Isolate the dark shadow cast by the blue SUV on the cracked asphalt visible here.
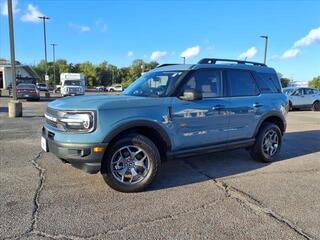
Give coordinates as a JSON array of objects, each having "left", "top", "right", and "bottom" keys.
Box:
[{"left": 147, "top": 130, "right": 320, "bottom": 191}]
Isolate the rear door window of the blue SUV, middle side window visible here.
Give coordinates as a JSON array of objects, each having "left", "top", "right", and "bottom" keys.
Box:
[{"left": 227, "top": 70, "right": 259, "bottom": 97}]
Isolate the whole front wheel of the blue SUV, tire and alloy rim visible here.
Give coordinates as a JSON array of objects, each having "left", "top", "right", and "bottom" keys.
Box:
[{"left": 101, "top": 134, "right": 161, "bottom": 192}]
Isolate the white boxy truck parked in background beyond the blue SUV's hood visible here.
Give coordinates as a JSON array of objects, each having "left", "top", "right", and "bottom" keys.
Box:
[{"left": 60, "top": 73, "right": 86, "bottom": 97}]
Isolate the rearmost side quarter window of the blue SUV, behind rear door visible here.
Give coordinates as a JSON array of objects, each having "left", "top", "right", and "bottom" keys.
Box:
[{"left": 255, "top": 73, "right": 281, "bottom": 93}]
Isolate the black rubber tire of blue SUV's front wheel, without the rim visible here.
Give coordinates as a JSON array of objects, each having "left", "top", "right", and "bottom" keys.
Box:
[{"left": 101, "top": 134, "right": 161, "bottom": 192}]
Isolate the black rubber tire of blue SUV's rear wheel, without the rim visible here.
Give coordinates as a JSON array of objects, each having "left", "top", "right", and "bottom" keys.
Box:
[{"left": 250, "top": 123, "right": 282, "bottom": 163}]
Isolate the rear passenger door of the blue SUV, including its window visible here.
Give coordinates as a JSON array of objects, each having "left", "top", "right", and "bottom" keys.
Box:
[{"left": 226, "top": 69, "right": 266, "bottom": 142}]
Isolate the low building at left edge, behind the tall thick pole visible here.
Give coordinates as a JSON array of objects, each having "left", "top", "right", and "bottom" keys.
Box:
[{"left": 0, "top": 60, "right": 38, "bottom": 89}]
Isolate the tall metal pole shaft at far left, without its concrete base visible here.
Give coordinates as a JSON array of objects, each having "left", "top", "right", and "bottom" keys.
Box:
[{"left": 8, "top": 0, "right": 17, "bottom": 100}]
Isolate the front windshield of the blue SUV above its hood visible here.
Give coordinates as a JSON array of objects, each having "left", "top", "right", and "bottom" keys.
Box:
[{"left": 123, "top": 71, "right": 183, "bottom": 97}]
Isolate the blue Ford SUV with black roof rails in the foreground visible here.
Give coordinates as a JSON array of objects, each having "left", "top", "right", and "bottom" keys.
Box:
[{"left": 41, "top": 58, "right": 288, "bottom": 192}]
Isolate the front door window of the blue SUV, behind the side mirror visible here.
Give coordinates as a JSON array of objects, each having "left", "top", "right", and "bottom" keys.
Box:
[{"left": 183, "top": 69, "right": 222, "bottom": 98}]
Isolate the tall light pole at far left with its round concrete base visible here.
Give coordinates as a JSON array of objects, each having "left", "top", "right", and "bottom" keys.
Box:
[{"left": 7, "top": 0, "right": 22, "bottom": 117}]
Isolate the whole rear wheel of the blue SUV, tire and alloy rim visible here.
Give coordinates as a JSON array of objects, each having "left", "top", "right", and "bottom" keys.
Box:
[{"left": 250, "top": 123, "right": 282, "bottom": 162}]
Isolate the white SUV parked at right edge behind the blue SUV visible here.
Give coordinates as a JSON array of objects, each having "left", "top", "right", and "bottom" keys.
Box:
[{"left": 283, "top": 87, "right": 320, "bottom": 111}]
